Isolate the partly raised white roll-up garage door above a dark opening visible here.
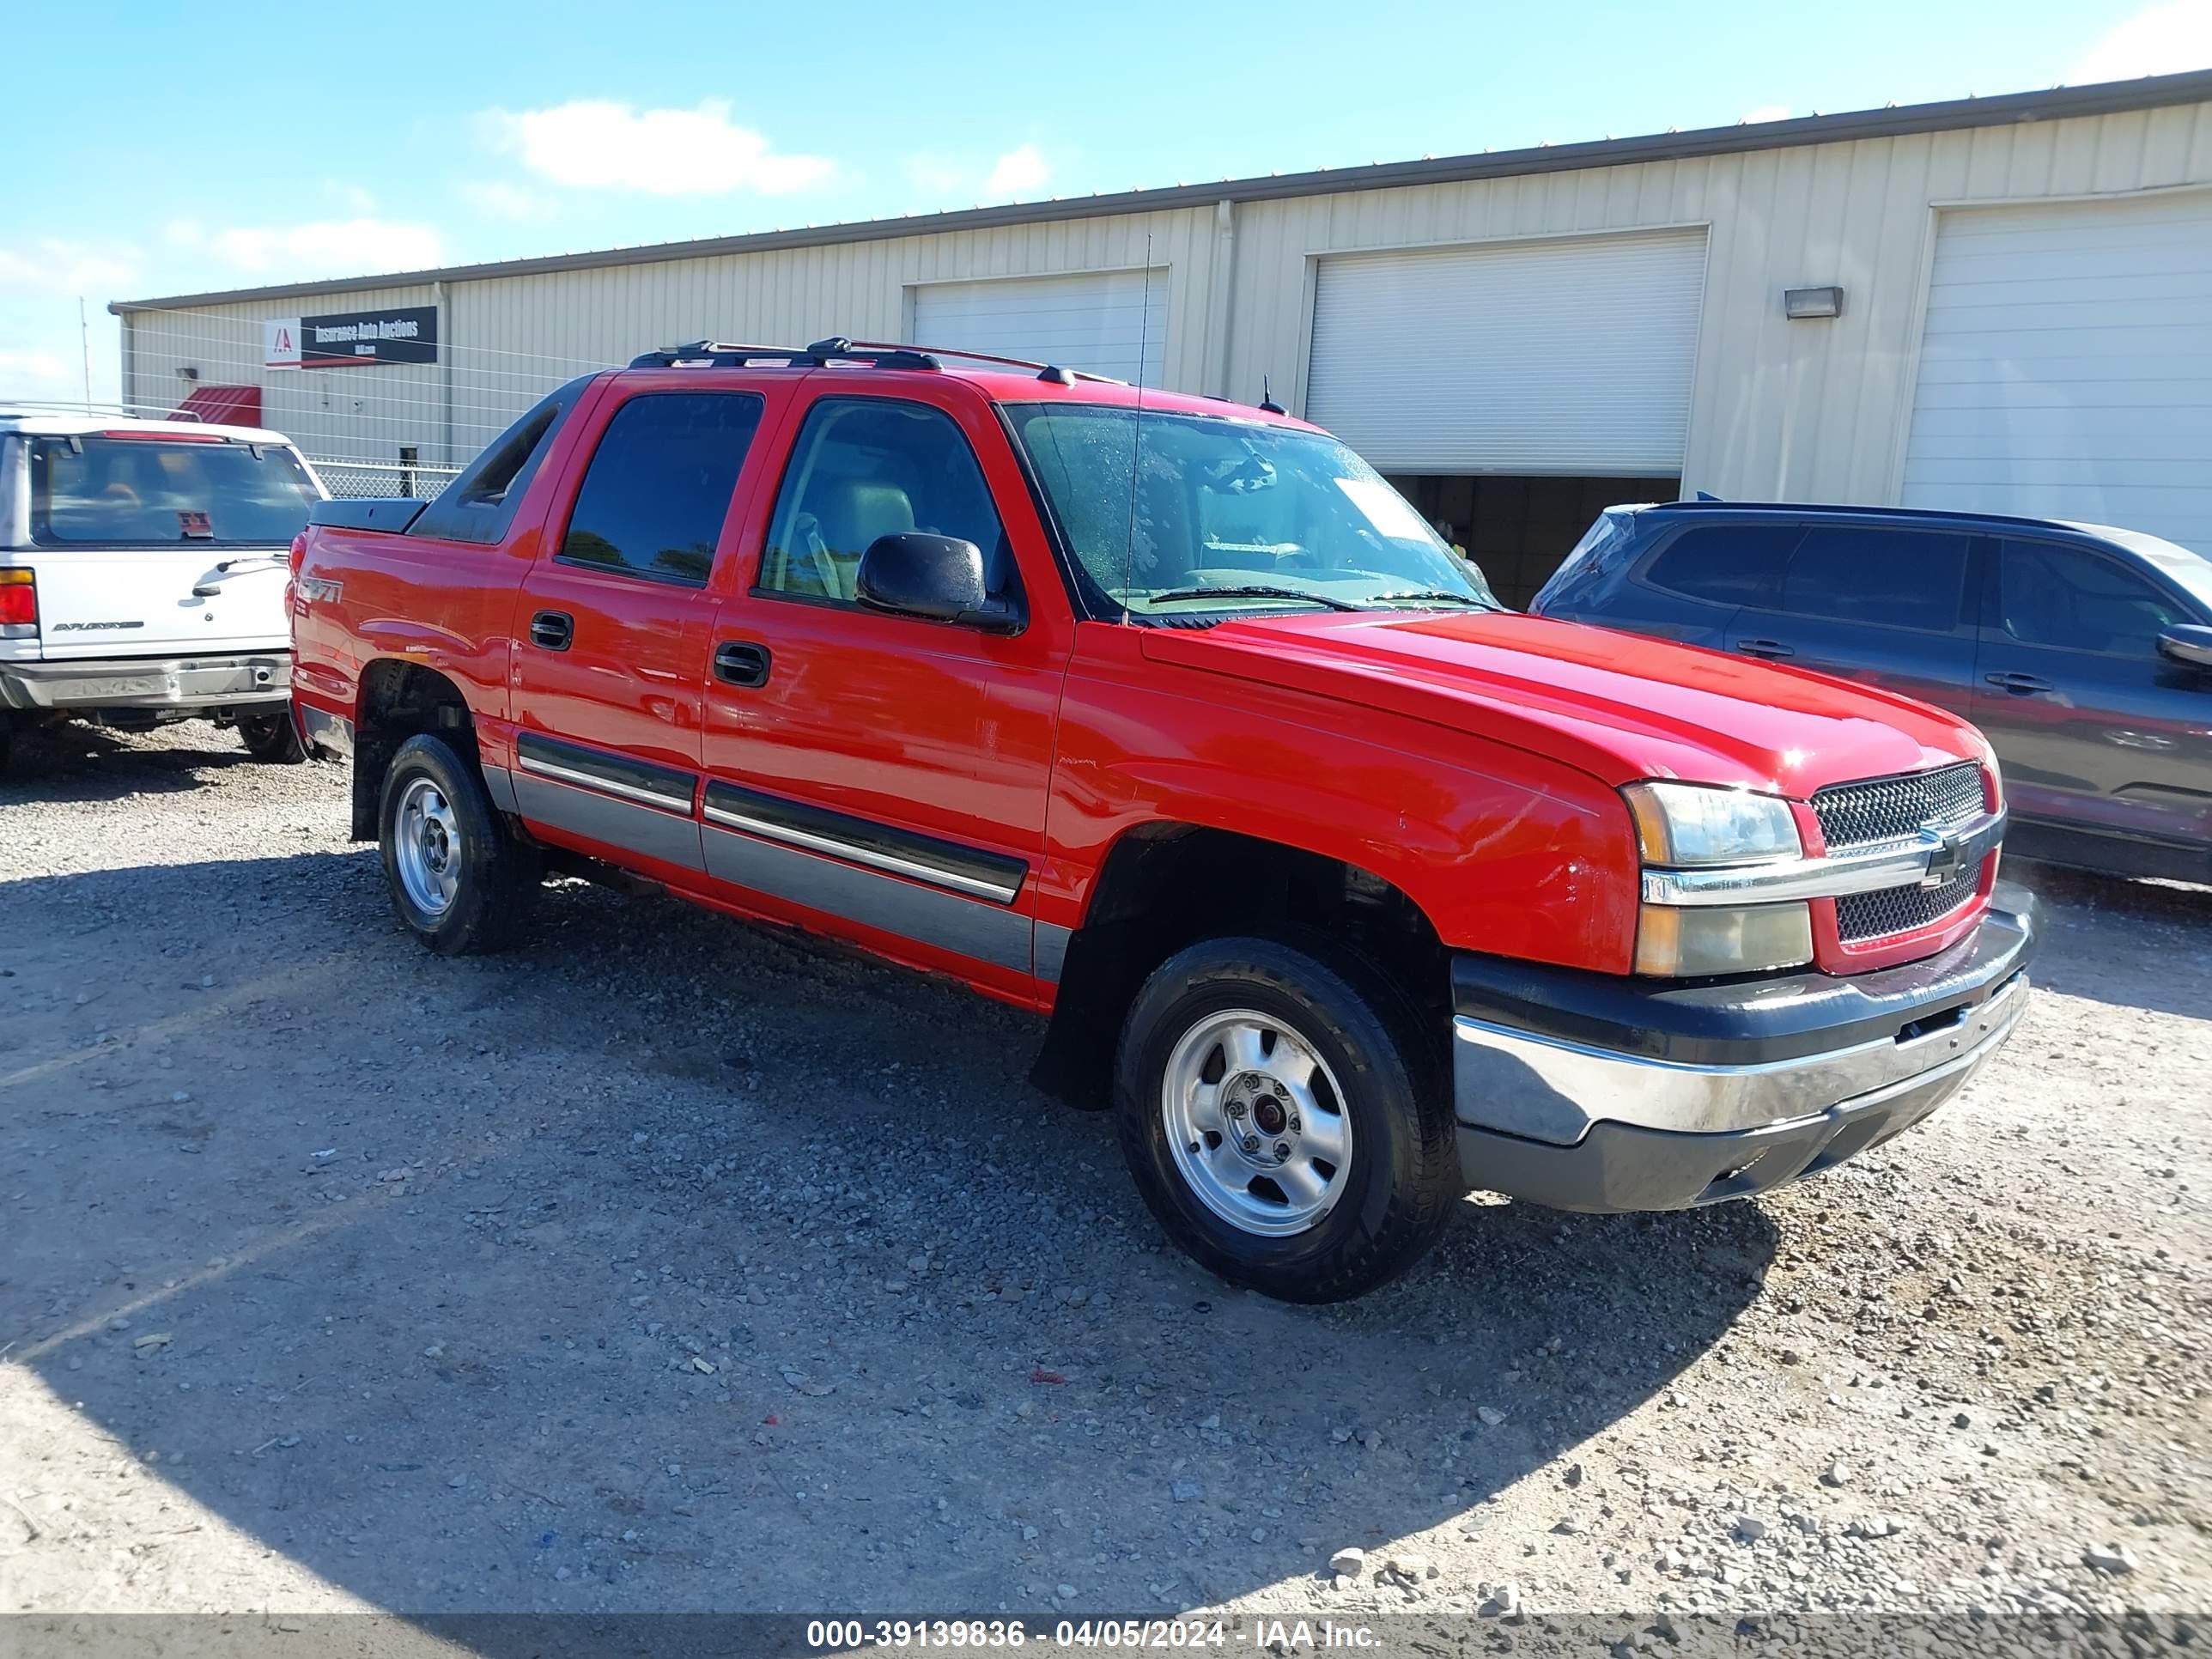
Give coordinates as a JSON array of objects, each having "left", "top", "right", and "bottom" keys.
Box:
[{"left": 1305, "top": 230, "right": 1705, "bottom": 476}]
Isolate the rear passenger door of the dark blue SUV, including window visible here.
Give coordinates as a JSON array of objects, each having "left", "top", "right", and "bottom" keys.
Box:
[{"left": 1729, "top": 522, "right": 1973, "bottom": 714}]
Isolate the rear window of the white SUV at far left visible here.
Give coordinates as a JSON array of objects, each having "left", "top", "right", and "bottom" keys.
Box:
[{"left": 31, "top": 435, "right": 319, "bottom": 546}]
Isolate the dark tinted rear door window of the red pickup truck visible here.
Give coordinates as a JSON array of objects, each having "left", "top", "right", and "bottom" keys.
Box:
[{"left": 556, "top": 392, "right": 763, "bottom": 586}]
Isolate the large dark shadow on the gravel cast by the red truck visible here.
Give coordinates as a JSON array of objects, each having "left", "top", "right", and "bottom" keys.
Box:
[{"left": 0, "top": 852, "right": 1777, "bottom": 1650}]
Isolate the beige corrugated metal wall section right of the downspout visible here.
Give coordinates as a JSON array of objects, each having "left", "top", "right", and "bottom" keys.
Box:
[{"left": 1228, "top": 93, "right": 2212, "bottom": 502}]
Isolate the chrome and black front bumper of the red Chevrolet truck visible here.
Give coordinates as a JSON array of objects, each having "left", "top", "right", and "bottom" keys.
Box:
[{"left": 1451, "top": 887, "right": 2037, "bottom": 1210}]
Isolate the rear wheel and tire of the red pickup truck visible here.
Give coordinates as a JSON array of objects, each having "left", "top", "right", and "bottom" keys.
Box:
[{"left": 376, "top": 734, "right": 540, "bottom": 956}]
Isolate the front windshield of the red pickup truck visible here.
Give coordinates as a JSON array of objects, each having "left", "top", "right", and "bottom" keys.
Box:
[{"left": 1009, "top": 403, "right": 1500, "bottom": 617}]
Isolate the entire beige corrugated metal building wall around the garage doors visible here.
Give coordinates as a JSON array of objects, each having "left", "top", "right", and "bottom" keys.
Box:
[{"left": 124, "top": 104, "right": 2212, "bottom": 502}]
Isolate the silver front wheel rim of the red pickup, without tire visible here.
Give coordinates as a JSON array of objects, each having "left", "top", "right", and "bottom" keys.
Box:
[{"left": 1159, "top": 1009, "right": 1352, "bottom": 1239}]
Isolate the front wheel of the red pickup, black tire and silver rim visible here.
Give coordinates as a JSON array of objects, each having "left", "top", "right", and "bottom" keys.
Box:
[{"left": 1115, "top": 938, "right": 1467, "bottom": 1303}]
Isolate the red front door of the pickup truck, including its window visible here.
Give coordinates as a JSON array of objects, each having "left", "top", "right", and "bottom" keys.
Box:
[{"left": 702, "top": 393, "right": 1071, "bottom": 1000}]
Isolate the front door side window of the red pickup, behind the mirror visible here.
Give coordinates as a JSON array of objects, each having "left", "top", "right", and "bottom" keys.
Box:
[{"left": 754, "top": 398, "right": 1013, "bottom": 604}]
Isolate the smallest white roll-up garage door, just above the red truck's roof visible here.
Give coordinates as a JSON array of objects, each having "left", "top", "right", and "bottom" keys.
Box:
[{"left": 914, "top": 270, "right": 1168, "bottom": 387}]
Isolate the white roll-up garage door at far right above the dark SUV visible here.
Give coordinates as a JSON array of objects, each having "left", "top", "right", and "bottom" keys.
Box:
[{"left": 1905, "top": 191, "right": 2212, "bottom": 553}]
